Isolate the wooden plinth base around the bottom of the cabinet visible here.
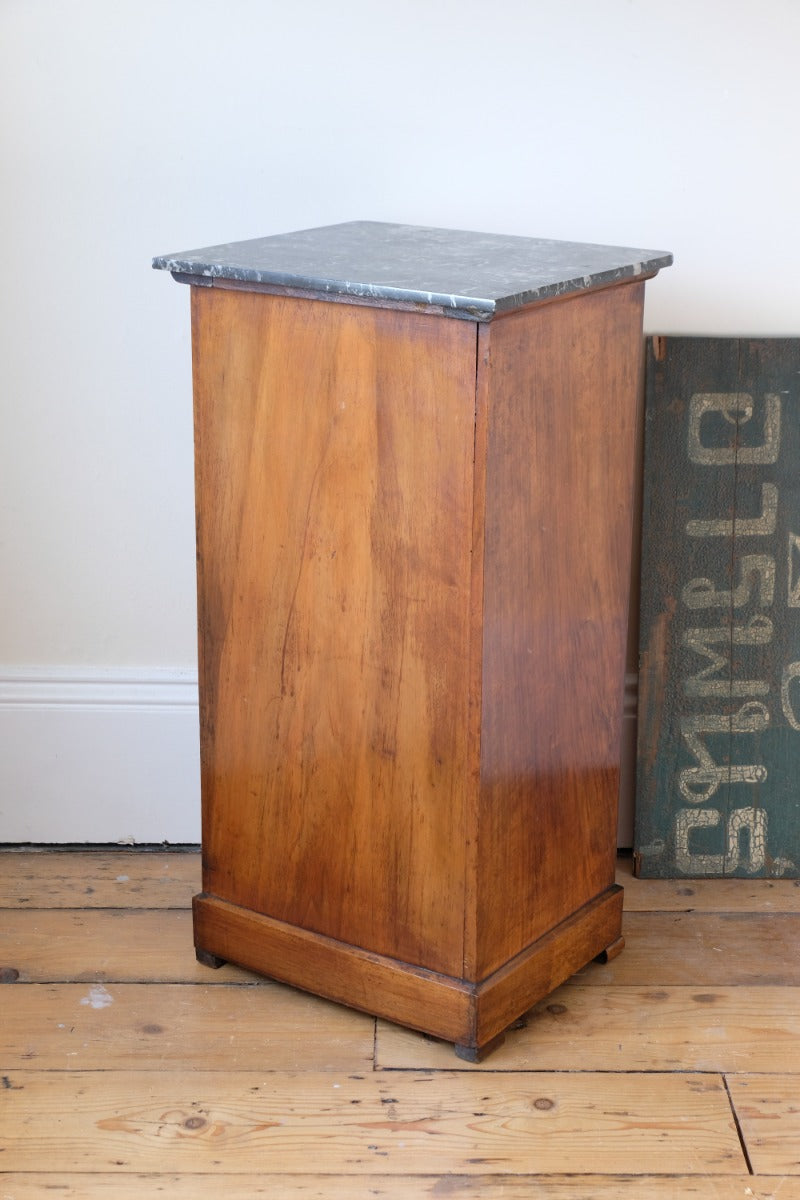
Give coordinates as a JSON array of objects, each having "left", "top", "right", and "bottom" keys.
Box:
[{"left": 193, "top": 884, "right": 622, "bottom": 1062}]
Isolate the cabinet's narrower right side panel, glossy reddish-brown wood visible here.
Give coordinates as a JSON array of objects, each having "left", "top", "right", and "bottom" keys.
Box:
[{"left": 479, "top": 284, "right": 644, "bottom": 978}]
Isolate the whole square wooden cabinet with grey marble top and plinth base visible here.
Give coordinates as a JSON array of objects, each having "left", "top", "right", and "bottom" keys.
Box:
[{"left": 154, "top": 222, "right": 672, "bottom": 1060}]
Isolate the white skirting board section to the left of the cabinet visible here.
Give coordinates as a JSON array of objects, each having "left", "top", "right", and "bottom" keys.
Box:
[{"left": 0, "top": 666, "right": 200, "bottom": 844}]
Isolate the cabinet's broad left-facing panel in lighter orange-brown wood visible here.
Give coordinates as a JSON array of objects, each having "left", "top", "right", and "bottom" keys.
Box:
[{"left": 193, "top": 288, "right": 475, "bottom": 976}]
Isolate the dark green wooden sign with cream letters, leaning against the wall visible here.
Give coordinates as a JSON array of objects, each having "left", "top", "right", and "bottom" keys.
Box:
[{"left": 634, "top": 337, "right": 800, "bottom": 878}]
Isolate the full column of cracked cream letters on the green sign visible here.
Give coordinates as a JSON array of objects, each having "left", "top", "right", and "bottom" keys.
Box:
[{"left": 674, "top": 392, "right": 800, "bottom": 875}]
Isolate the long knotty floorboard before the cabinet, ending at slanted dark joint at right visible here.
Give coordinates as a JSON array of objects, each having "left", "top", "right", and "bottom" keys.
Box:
[{"left": 0, "top": 1070, "right": 744, "bottom": 1176}]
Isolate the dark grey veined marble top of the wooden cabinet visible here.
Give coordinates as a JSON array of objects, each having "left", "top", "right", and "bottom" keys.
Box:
[{"left": 152, "top": 221, "right": 672, "bottom": 320}]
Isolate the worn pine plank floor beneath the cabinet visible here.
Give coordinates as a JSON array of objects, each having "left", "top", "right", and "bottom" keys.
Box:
[{"left": 0, "top": 852, "right": 800, "bottom": 1200}]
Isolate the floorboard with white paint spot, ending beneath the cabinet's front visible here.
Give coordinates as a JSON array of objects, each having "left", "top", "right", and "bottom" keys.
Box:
[{"left": 0, "top": 983, "right": 374, "bottom": 1070}]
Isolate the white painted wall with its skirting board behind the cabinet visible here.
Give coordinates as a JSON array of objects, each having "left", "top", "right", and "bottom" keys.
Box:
[{"left": 0, "top": 0, "right": 800, "bottom": 841}]
